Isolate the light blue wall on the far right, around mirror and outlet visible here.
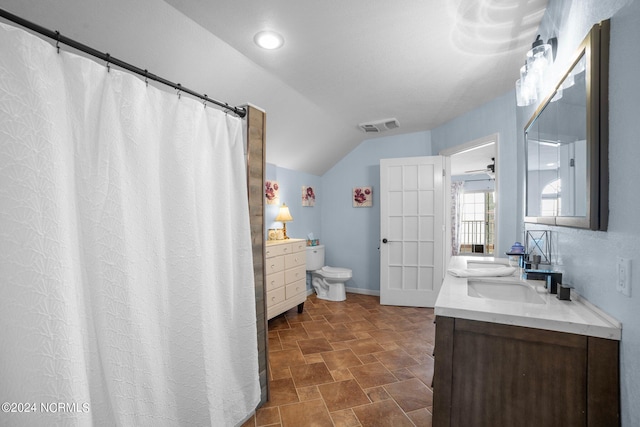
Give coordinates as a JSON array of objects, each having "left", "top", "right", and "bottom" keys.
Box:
[{"left": 518, "top": 0, "right": 640, "bottom": 427}]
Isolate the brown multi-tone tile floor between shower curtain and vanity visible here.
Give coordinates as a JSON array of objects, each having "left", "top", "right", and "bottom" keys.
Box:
[{"left": 243, "top": 293, "right": 435, "bottom": 427}]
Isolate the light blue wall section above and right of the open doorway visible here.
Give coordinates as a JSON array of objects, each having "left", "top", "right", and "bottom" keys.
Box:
[{"left": 431, "top": 91, "right": 524, "bottom": 256}]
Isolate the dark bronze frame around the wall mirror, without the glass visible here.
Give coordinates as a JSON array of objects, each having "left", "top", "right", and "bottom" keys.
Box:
[{"left": 524, "top": 20, "right": 610, "bottom": 231}]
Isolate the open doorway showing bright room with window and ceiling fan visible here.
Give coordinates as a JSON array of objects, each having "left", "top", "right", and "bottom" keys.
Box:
[{"left": 439, "top": 133, "right": 499, "bottom": 260}]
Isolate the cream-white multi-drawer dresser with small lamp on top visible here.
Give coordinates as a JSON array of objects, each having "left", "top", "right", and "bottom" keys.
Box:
[{"left": 265, "top": 239, "right": 307, "bottom": 319}]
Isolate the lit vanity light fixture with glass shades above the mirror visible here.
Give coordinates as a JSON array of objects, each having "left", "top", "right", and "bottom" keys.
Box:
[{"left": 516, "top": 35, "right": 558, "bottom": 107}]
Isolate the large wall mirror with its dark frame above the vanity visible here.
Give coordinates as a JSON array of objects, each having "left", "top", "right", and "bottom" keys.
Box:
[{"left": 525, "top": 21, "right": 609, "bottom": 230}]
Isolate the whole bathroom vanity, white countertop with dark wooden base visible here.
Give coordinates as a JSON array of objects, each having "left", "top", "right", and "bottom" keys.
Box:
[{"left": 433, "top": 257, "right": 621, "bottom": 427}]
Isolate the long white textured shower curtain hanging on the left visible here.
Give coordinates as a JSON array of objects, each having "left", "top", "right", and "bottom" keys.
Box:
[{"left": 0, "top": 24, "right": 260, "bottom": 426}]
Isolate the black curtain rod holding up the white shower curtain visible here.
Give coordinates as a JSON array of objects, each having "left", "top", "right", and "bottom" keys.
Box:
[{"left": 0, "top": 9, "right": 247, "bottom": 118}]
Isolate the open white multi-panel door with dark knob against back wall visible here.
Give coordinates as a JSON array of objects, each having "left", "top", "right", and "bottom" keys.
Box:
[{"left": 380, "top": 156, "right": 445, "bottom": 307}]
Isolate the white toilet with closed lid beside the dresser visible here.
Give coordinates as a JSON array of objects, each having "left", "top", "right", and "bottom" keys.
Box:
[{"left": 307, "top": 245, "right": 351, "bottom": 301}]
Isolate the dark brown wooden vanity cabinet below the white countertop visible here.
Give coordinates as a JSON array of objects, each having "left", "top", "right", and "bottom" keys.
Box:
[{"left": 433, "top": 316, "right": 620, "bottom": 427}]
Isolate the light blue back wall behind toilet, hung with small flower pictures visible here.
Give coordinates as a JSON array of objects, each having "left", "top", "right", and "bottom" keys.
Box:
[{"left": 265, "top": 132, "right": 431, "bottom": 295}]
